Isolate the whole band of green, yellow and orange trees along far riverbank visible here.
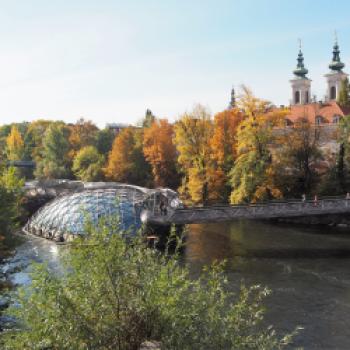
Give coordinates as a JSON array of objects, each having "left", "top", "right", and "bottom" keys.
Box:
[{"left": 0, "top": 88, "right": 350, "bottom": 203}]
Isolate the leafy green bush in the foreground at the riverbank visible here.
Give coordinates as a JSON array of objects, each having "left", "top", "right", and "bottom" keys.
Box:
[{"left": 2, "top": 225, "right": 298, "bottom": 350}]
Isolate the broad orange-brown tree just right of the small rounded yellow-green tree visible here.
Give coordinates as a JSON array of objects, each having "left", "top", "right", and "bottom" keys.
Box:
[{"left": 104, "top": 127, "right": 151, "bottom": 186}]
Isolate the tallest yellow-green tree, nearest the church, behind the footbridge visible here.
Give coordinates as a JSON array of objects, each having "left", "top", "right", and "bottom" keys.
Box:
[{"left": 230, "top": 88, "right": 285, "bottom": 204}]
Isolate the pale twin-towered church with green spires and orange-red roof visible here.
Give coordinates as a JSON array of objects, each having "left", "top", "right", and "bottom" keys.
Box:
[{"left": 286, "top": 40, "right": 350, "bottom": 127}]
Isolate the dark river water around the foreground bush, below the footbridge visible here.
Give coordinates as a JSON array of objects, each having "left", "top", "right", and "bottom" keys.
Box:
[{"left": 2, "top": 221, "right": 350, "bottom": 349}]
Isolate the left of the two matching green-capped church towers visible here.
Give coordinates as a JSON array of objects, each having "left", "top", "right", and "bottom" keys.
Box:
[{"left": 290, "top": 45, "right": 311, "bottom": 105}]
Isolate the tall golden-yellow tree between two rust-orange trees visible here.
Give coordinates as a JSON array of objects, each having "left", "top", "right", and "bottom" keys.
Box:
[{"left": 174, "top": 105, "right": 213, "bottom": 203}]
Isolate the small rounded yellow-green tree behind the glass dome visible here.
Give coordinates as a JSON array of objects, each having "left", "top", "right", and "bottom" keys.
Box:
[{"left": 72, "top": 146, "right": 104, "bottom": 181}]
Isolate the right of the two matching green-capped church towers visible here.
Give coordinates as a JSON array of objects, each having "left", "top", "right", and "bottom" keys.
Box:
[{"left": 325, "top": 39, "right": 348, "bottom": 101}]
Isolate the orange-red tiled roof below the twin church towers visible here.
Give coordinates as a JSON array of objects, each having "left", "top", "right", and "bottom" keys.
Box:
[{"left": 286, "top": 101, "right": 350, "bottom": 124}]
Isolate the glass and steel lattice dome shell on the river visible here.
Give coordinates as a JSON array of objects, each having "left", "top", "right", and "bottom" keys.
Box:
[{"left": 24, "top": 189, "right": 141, "bottom": 241}]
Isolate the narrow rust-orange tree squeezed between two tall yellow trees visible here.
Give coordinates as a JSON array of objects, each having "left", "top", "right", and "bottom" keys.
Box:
[{"left": 210, "top": 108, "right": 242, "bottom": 202}]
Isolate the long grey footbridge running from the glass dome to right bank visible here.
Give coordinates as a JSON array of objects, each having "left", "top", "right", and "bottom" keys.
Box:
[{"left": 143, "top": 196, "right": 350, "bottom": 225}]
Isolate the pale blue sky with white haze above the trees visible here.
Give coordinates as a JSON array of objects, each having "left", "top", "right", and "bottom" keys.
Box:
[{"left": 0, "top": 0, "right": 350, "bottom": 127}]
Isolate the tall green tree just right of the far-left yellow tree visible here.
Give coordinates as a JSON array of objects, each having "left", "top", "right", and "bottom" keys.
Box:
[{"left": 35, "top": 124, "right": 71, "bottom": 179}]
